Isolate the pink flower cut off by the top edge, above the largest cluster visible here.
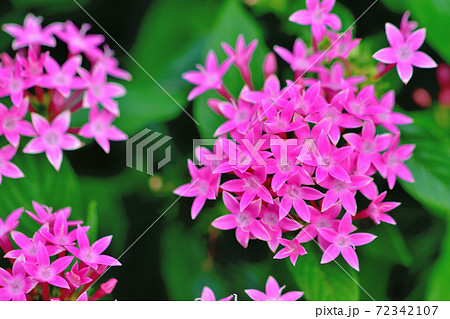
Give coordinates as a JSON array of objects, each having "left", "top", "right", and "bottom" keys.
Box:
[{"left": 289, "top": 0, "right": 342, "bottom": 42}]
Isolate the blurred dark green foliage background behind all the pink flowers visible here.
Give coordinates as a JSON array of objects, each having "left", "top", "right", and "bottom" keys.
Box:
[{"left": 0, "top": 0, "right": 450, "bottom": 300}]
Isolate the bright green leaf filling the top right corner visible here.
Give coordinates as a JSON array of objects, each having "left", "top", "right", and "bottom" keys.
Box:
[{"left": 383, "top": 0, "right": 450, "bottom": 62}]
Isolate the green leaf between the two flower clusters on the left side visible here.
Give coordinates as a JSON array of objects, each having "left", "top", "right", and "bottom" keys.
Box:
[{"left": 0, "top": 153, "right": 84, "bottom": 233}]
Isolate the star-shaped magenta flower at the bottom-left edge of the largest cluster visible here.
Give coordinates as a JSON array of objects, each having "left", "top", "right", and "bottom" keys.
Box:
[{"left": 211, "top": 192, "right": 270, "bottom": 248}]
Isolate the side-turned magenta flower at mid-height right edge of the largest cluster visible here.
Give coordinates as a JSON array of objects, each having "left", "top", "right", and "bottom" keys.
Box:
[{"left": 383, "top": 135, "right": 415, "bottom": 189}]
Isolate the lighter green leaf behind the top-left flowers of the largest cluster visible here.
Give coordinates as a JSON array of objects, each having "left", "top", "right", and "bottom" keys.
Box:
[{"left": 193, "top": 0, "right": 268, "bottom": 138}]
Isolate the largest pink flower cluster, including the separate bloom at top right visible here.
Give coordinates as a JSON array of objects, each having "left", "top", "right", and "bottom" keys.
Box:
[{"left": 174, "top": 0, "right": 431, "bottom": 270}]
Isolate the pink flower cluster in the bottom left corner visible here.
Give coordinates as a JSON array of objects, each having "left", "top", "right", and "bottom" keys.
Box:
[{"left": 0, "top": 202, "right": 121, "bottom": 301}]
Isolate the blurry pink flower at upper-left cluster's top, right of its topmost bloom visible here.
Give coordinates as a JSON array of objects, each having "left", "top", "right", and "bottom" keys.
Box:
[{"left": 56, "top": 21, "right": 105, "bottom": 58}]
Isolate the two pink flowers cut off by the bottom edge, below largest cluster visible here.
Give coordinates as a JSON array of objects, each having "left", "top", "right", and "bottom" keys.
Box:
[{"left": 195, "top": 276, "right": 303, "bottom": 301}]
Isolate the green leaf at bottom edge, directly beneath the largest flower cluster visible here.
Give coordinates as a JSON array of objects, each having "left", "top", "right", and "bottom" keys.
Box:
[{"left": 288, "top": 247, "right": 359, "bottom": 301}]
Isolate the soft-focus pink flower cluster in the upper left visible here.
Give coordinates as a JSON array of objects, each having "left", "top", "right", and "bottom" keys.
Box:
[{"left": 0, "top": 14, "right": 131, "bottom": 178}]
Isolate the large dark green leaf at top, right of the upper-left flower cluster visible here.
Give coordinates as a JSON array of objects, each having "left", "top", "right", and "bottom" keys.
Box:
[{"left": 117, "top": 0, "right": 219, "bottom": 134}]
